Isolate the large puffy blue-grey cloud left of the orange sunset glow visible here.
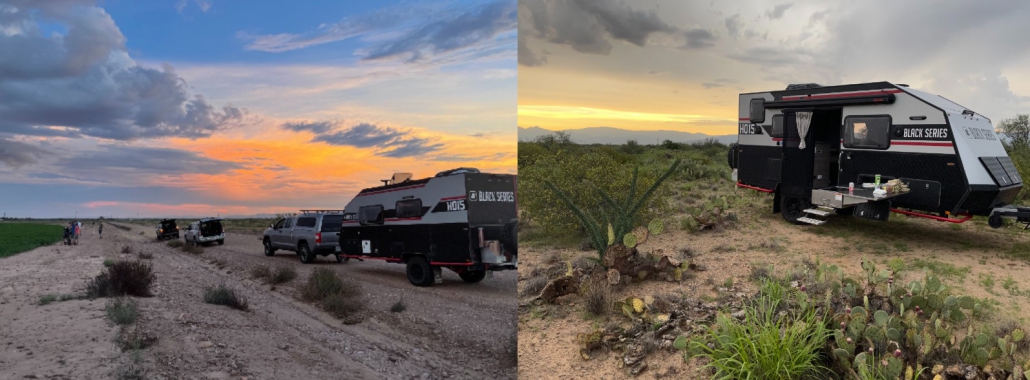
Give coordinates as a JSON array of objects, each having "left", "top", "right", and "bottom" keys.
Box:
[{"left": 0, "top": 1, "right": 245, "bottom": 140}]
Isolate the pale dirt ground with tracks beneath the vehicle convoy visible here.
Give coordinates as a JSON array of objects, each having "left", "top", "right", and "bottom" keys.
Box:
[{"left": 0, "top": 220, "right": 516, "bottom": 379}]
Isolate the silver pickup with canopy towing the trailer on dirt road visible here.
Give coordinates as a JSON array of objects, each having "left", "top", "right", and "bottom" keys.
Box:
[{"left": 262, "top": 210, "right": 347, "bottom": 264}]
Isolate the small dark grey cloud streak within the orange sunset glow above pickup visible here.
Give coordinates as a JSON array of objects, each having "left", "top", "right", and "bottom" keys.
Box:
[{"left": 280, "top": 122, "right": 444, "bottom": 158}]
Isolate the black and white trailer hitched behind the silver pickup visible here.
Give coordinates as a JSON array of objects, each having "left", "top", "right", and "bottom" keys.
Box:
[{"left": 340, "top": 168, "right": 518, "bottom": 286}]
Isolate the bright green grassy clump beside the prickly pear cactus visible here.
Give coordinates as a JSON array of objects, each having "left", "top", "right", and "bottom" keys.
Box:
[{"left": 691, "top": 281, "right": 830, "bottom": 379}]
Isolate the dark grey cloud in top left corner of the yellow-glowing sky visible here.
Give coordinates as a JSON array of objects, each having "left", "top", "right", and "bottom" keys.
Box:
[{"left": 519, "top": 0, "right": 688, "bottom": 66}]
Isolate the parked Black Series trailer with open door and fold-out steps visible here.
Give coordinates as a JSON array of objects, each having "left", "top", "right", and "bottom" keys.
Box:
[{"left": 728, "top": 81, "right": 1030, "bottom": 228}]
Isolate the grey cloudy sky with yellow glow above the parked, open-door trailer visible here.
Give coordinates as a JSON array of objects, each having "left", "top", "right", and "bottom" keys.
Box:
[{"left": 518, "top": 0, "right": 1030, "bottom": 135}]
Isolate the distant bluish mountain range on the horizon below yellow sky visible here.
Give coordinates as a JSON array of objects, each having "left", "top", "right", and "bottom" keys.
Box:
[{"left": 518, "top": 127, "right": 736, "bottom": 144}]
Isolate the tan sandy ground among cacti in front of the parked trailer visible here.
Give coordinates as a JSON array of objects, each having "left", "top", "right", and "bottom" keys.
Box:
[{"left": 518, "top": 199, "right": 1030, "bottom": 379}]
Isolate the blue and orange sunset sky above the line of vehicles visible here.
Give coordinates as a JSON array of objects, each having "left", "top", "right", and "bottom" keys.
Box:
[{"left": 0, "top": 0, "right": 518, "bottom": 217}]
